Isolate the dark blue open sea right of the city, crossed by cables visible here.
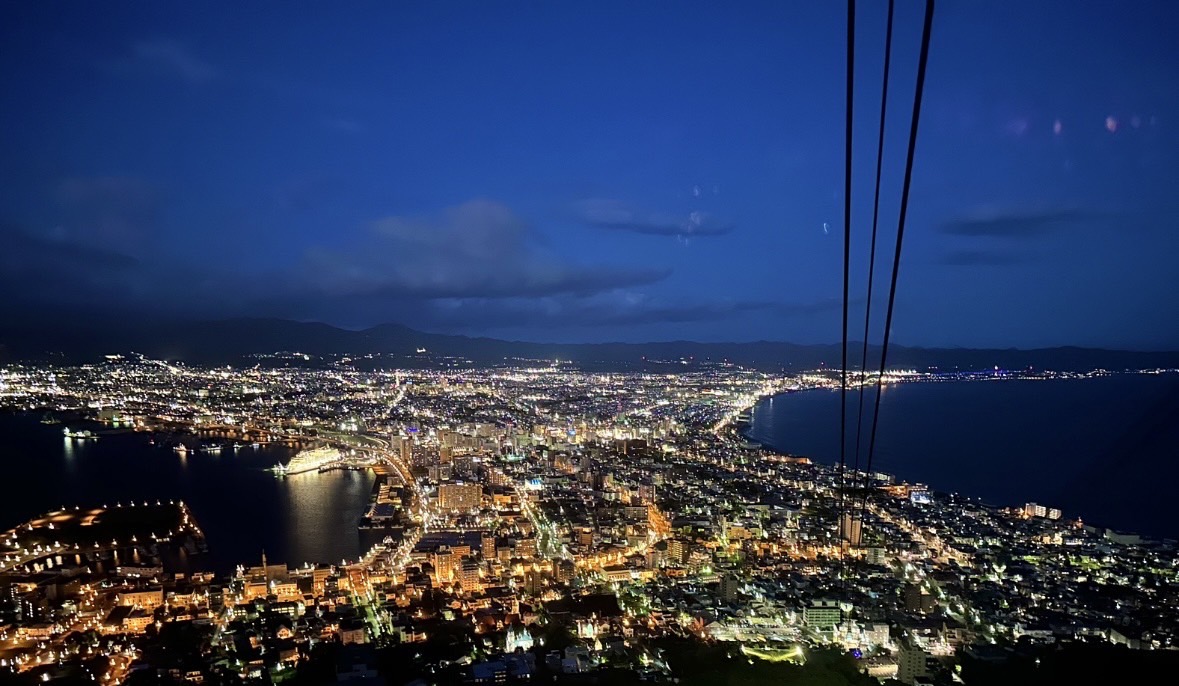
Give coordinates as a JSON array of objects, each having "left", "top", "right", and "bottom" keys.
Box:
[{"left": 747, "top": 374, "right": 1179, "bottom": 537}]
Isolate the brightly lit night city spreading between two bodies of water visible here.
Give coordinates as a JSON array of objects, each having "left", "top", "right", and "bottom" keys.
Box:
[{"left": 0, "top": 356, "right": 1179, "bottom": 684}]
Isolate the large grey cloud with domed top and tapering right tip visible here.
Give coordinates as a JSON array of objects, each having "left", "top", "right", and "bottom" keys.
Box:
[{"left": 301, "top": 200, "right": 668, "bottom": 298}]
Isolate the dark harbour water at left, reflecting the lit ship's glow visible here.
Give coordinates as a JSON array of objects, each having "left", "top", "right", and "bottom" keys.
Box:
[{"left": 0, "top": 413, "right": 374, "bottom": 572}]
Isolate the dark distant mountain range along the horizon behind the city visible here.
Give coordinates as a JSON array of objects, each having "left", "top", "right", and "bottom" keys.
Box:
[{"left": 0, "top": 317, "right": 1179, "bottom": 371}]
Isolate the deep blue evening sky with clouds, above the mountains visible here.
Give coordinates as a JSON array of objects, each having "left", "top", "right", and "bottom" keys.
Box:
[{"left": 0, "top": 0, "right": 1179, "bottom": 348}]
